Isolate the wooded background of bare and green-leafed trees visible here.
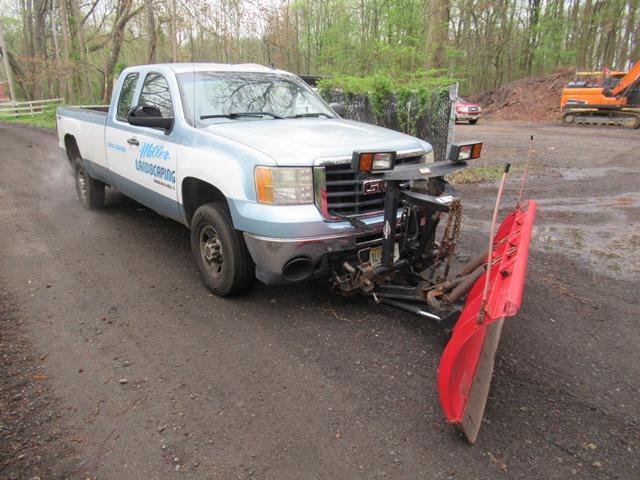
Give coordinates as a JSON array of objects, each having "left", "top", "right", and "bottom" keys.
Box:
[{"left": 0, "top": 0, "right": 640, "bottom": 104}]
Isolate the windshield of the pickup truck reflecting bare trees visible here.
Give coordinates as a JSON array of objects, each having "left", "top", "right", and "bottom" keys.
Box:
[{"left": 177, "top": 72, "right": 335, "bottom": 127}]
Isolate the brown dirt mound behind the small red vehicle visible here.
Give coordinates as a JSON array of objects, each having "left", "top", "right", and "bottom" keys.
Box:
[{"left": 469, "top": 70, "right": 573, "bottom": 122}]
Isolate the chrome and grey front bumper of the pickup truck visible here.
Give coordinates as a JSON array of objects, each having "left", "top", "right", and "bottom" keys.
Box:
[{"left": 244, "top": 222, "right": 382, "bottom": 285}]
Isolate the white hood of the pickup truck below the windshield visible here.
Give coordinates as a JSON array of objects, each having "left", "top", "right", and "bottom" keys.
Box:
[{"left": 206, "top": 118, "right": 431, "bottom": 166}]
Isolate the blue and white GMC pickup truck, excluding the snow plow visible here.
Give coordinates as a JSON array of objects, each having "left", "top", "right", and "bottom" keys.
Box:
[{"left": 57, "top": 64, "right": 433, "bottom": 295}]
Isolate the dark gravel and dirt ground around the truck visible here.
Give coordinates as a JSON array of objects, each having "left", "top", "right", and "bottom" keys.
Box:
[{"left": 0, "top": 119, "right": 640, "bottom": 480}]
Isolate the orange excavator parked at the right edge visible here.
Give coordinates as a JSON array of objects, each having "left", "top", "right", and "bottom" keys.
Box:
[{"left": 560, "top": 61, "right": 640, "bottom": 128}]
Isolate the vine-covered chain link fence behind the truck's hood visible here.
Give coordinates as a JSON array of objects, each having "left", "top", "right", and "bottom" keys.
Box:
[{"left": 322, "top": 86, "right": 457, "bottom": 161}]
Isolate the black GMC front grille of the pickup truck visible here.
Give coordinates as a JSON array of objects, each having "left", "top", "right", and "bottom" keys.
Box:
[{"left": 325, "top": 156, "right": 422, "bottom": 217}]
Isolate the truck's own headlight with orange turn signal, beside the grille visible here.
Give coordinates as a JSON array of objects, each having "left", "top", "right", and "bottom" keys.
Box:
[{"left": 255, "top": 167, "right": 313, "bottom": 205}]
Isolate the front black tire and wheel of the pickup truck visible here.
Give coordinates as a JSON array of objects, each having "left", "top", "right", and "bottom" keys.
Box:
[{"left": 191, "top": 202, "right": 255, "bottom": 297}]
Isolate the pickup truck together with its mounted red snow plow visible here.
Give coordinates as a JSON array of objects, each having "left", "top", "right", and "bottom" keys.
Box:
[{"left": 57, "top": 65, "right": 536, "bottom": 443}]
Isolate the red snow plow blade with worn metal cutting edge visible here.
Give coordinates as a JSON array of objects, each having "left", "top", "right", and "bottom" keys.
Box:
[{"left": 438, "top": 200, "right": 536, "bottom": 444}]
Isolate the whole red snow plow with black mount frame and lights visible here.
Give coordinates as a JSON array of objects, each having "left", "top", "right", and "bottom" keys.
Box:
[{"left": 333, "top": 142, "right": 536, "bottom": 443}]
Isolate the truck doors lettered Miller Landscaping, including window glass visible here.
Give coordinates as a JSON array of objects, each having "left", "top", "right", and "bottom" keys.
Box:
[{"left": 107, "top": 72, "right": 181, "bottom": 221}]
